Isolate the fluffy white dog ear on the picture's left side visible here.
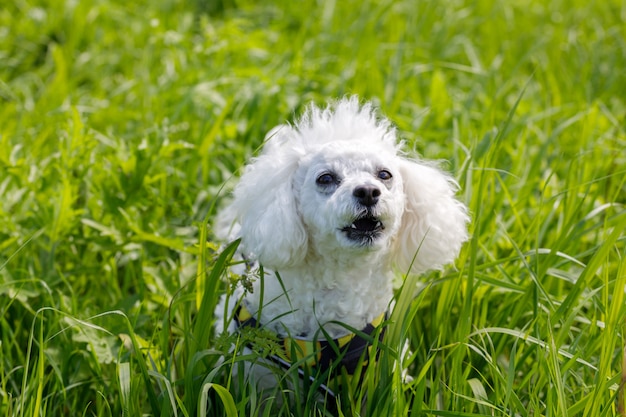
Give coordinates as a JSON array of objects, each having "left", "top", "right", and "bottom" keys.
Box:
[{"left": 227, "top": 125, "right": 308, "bottom": 269}]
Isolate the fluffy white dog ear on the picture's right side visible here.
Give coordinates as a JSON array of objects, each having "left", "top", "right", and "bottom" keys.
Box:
[{"left": 393, "top": 159, "right": 469, "bottom": 273}]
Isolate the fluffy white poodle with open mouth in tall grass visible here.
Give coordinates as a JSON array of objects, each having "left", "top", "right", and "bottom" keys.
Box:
[{"left": 217, "top": 97, "right": 468, "bottom": 402}]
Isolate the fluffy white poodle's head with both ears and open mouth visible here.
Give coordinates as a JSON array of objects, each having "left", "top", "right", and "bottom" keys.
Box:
[{"left": 224, "top": 97, "right": 468, "bottom": 272}]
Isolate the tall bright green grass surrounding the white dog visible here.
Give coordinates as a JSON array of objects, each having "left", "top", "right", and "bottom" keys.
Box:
[{"left": 0, "top": 0, "right": 626, "bottom": 417}]
